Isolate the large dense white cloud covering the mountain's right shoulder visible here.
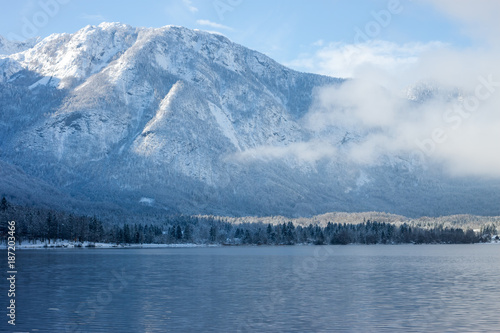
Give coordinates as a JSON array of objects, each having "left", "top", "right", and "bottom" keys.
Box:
[{"left": 298, "top": 43, "right": 500, "bottom": 177}]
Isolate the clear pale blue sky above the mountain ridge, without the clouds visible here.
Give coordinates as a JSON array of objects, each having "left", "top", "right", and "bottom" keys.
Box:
[{"left": 0, "top": 0, "right": 474, "bottom": 74}]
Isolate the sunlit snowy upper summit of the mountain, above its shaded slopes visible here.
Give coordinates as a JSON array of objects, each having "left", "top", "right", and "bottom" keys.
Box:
[{"left": 3, "top": 22, "right": 290, "bottom": 88}]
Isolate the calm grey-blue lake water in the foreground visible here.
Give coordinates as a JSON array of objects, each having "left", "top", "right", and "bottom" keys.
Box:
[{"left": 5, "top": 245, "right": 500, "bottom": 332}]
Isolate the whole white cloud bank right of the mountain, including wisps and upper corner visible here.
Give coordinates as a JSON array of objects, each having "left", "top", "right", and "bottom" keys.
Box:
[{"left": 236, "top": 0, "right": 500, "bottom": 178}]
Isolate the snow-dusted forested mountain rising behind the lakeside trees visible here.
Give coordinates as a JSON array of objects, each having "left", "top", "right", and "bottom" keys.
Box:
[{"left": 0, "top": 23, "right": 500, "bottom": 215}]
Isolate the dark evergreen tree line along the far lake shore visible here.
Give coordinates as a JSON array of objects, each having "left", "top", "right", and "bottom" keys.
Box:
[{"left": 0, "top": 198, "right": 497, "bottom": 245}]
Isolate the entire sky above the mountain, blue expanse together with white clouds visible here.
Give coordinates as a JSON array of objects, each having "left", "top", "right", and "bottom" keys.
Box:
[{"left": 0, "top": 0, "right": 500, "bottom": 178}]
